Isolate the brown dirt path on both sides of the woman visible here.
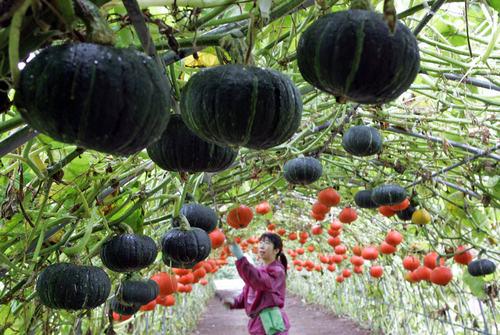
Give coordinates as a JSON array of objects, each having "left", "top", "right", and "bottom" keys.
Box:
[{"left": 192, "top": 291, "right": 370, "bottom": 335}]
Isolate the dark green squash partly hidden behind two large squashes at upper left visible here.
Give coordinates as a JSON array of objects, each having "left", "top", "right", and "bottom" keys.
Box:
[{"left": 148, "top": 115, "right": 238, "bottom": 172}]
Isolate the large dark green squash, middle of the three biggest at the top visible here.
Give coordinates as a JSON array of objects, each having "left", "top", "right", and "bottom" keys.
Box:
[{"left": 181, "top": 65, "right": 302, "bottom": 149}]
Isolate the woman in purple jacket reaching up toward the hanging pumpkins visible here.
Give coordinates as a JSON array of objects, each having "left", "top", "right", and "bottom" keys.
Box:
[{"left": 224, "top": 233, "right": 290, "bottom": 335}]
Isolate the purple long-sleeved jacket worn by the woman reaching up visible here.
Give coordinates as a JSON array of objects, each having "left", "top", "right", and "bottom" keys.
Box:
[{"left": 231, "top": 257, "right": 290, "bottom": 335}]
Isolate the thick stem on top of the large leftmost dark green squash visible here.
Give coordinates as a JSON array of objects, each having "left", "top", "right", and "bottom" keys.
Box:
[{"left": 74, "top": 0, "right": 115, "bottom": 45}]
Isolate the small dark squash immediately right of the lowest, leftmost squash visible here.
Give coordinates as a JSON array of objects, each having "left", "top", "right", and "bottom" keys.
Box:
[{"left": 118, "top": 279, "right": 160, "bottom": 305}]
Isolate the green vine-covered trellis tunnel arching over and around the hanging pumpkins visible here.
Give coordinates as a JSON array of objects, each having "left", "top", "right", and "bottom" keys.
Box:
[{"left": 0, "top": 0, "right": 500, "bottom": 334}]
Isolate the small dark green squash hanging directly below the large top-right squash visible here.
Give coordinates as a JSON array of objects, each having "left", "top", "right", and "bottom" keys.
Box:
[{"left": 342, "top": 126, "right": 382, "bottom": 157}]
